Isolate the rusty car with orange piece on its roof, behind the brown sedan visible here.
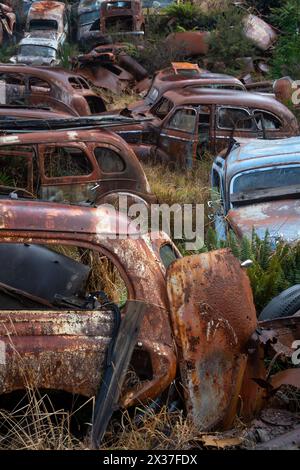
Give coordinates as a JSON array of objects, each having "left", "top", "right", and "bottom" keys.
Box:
[{"left": 129, "top": 62, "right": 246, "bottom": 112}]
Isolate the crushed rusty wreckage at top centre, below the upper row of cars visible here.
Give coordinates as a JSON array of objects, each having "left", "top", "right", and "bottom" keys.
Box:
[{"left": 72, "top": 44, "right": 149, "bottom": 93}]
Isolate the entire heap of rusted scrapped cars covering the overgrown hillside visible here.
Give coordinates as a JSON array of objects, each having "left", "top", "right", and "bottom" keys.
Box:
[{"left": 0, "top": 0, "right": 300, "bottom": 447}]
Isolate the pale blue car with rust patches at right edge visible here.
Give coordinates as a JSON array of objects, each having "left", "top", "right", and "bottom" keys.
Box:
[{"left": 211, "top": 137, "right": 300, "bottom": 242}]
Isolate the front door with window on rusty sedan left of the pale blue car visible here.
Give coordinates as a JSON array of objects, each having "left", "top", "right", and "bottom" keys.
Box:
[{"left": 155, "top": 106, "right": 198, "bottom": 169}]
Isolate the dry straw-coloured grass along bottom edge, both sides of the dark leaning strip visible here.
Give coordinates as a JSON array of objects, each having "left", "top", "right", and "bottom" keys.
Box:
[{"left": 0, "top": 388, "right": 199, "bottom": 450}]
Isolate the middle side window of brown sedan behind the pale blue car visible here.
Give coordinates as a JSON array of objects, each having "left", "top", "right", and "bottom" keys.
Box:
[{"left": 218, "top": 107, "right": 256, "bottom": 131}]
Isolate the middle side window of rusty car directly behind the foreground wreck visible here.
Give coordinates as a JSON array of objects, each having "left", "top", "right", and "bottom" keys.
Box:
[{"left": 44, "top": 146, "right": 93, "bottom": 178}]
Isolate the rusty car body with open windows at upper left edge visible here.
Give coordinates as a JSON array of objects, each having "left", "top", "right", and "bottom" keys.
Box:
[{"left": 0, "top": 65, "right": 106, "bottom": 116}]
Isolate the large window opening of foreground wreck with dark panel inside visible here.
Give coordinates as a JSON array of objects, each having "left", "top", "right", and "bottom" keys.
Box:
[{"left": 0, "top": 243, "right": 128, "bottom": 310}]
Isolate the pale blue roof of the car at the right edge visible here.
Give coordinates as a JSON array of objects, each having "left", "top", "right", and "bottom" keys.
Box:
[{"left": 225, "top": 137, "right": 300, "bottom": 180}]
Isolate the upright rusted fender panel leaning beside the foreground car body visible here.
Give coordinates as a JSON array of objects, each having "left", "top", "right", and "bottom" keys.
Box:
[{"left": 167, "top": 250, "right": 261, "bottom": 430}]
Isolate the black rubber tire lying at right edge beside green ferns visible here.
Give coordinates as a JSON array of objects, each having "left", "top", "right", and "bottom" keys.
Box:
[{"left": 258, "top": 284, "right": 300, "bottom": 321}]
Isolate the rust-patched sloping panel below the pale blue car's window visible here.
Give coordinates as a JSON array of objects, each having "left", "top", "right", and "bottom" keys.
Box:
[{"left": 227, "top": 199, "right": 300, "bottom": 242}]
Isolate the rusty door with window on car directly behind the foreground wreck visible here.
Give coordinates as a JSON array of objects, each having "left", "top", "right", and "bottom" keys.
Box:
[{"left": 39, "top": 142, "right": 100, "bottom": 204}]
